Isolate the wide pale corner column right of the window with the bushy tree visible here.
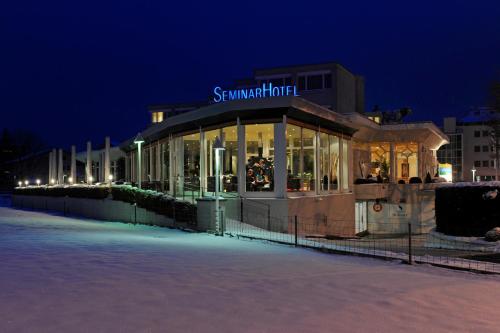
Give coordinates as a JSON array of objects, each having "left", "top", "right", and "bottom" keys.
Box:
[{"left": 274, "top": 116, "right": 287, "bottom": 198}]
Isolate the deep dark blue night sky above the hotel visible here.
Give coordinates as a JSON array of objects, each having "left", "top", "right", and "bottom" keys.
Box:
[{"left": 0, "top": 0, "right": 500, "bottom": 146}]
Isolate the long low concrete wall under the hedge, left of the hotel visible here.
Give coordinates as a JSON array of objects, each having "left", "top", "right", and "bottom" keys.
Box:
[{"left": 12, "top": 195, "right": 176, "bottom": 227}]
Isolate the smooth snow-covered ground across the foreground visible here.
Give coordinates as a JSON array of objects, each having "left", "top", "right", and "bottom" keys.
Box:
[{"left": 0, "top": 198, "right": 500, "bottom": 332}]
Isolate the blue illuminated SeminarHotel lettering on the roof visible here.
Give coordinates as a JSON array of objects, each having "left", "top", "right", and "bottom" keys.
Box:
[{"left": 214, "top": 82, "right": 299, "bottom": 103}]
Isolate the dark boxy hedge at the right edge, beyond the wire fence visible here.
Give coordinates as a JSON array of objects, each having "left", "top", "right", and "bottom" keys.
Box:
[{"left": 435, "top": 183, "right": 500, "bottom": 237}]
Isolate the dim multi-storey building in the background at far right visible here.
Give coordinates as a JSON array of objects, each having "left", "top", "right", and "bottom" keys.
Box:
[{"left": 437, "top": 107, "right": 497, "bottom": 182}]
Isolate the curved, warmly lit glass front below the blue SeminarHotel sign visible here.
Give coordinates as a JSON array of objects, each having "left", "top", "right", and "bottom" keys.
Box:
[{"left": 131, "top": 123, "right": 350, "bottom": 196}]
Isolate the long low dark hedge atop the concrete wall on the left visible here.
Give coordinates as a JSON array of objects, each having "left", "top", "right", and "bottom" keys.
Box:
[{"left": 14, "top": 185, "right": 196, "bottom": 224}]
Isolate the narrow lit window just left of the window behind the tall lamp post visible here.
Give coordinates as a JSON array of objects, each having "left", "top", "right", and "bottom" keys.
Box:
[{"left": 182, "top": 133, "right": 200, "bottom": 191}]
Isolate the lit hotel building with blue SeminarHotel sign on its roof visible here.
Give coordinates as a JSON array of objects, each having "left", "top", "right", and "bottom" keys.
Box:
[{"left": 121, "top": 63, "right": 448, "bottom": 234}]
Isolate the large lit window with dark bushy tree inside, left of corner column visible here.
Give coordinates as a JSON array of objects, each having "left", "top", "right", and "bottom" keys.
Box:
[{"left": 245, "top": 124, "right": 274, "bottom": 192}]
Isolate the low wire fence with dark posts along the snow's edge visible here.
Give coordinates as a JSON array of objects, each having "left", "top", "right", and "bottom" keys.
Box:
[{"left": 224, "top": 216, "right": 500, "bottom": 274}]
